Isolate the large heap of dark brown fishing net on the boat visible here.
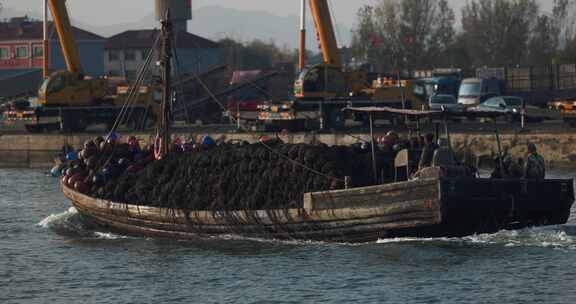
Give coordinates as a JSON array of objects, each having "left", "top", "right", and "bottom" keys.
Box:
[{"left": 92, "top": 142, "right": 373, "bottom": 210}]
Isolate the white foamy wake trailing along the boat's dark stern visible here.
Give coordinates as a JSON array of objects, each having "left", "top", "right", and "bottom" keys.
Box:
[{"left": 377, "top": 226, "right": 576, "bottom": 250}]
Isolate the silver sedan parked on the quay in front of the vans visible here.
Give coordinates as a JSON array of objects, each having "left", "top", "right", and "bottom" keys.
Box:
[{"left": 469, "top": 96, "right": 550, "bottom": 122}]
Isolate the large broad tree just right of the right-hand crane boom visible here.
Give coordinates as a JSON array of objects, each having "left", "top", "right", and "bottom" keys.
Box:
[{"left": 353, "top": 0, "right": 455, "bottom": 69}]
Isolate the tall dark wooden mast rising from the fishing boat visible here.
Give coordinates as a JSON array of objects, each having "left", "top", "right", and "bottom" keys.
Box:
[{"left": 155, "top": 10, "right": 173, "bottom": 159}]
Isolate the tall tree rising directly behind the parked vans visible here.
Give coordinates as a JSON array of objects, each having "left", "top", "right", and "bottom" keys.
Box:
[{"left": 462, "top": 0, "right": 548, "bottom": 66}]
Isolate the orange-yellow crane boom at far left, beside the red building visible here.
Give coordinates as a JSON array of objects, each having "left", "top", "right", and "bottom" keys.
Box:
[{"left": 48, "top": 0, "right": 84, "bottom": 74}]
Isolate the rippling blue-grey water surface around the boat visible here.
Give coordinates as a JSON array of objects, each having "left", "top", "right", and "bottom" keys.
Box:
[{"left": 0, "top": 170, "right": 576, "bottom": 303}]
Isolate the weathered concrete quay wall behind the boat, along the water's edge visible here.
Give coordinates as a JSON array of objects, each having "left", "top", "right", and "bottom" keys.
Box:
[{"left": 0, "top": 131, "right": 576, "bottom": 168}]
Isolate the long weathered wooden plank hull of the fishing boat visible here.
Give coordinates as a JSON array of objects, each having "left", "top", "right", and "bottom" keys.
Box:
[{"left": 63, "top": 179, "right": 574, "bottom": 242}]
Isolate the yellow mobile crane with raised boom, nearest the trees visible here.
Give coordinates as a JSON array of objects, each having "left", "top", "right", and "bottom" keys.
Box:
[{"left": 259, "top": 0, "right": 428, "bottom": 130}]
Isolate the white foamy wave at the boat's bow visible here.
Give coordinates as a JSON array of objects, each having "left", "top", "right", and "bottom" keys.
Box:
[{"left": 38, "top": 207, "right": 125, "bottom": 240}]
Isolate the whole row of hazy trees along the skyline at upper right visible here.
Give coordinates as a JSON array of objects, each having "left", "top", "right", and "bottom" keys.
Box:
[{"left": 351, "top": 0, "right": 576, "bottom": 70}]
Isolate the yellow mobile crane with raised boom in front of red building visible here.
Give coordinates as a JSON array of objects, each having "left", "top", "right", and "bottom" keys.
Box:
[{"left": 26, "top": 0, "right": 157, "bottom": 132}]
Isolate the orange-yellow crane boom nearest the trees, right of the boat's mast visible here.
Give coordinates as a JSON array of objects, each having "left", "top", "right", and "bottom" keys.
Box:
[{"left": 310, "top": 0, "right": 342, "bottom": 67}]
